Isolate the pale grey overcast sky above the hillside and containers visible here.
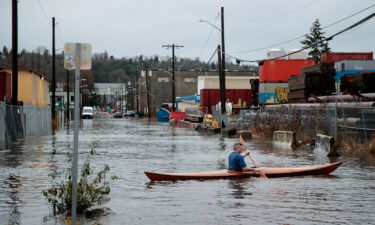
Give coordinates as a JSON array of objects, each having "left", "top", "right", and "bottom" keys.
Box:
[{"left": 0, "top": 0, "right": 375, "bottom": 61}]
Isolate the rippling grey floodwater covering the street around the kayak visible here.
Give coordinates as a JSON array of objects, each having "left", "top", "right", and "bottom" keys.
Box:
[{"left": 0, "top": 118, "right": 375, "bottom": 225}]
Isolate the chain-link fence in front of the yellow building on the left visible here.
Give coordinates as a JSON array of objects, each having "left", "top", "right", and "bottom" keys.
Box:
[{"left": 0, "top": 102, "right": 52, "bottom": 147}]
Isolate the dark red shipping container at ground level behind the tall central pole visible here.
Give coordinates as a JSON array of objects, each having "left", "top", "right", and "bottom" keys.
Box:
[{"left": 200, "top": 89, "right": 252, "bottom": 113}]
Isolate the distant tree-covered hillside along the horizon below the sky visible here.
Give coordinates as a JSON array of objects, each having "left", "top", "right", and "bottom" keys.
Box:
[{"left": 0, "top": 46, "right": 256, "bottom": 83}]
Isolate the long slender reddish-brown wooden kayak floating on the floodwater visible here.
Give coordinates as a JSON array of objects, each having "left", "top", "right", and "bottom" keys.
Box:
[{"left": 145, "top": 162, "right": 342, "bottom": 181}]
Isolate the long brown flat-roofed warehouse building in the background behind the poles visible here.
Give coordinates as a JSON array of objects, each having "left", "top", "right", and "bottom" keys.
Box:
[{"left": 137, "top": 70, "right": 258, "bottom": 113}]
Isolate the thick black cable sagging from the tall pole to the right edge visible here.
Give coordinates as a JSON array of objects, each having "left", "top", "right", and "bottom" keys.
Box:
[{"left": 223, "top": 13, "right": 375, "bottom": 63}]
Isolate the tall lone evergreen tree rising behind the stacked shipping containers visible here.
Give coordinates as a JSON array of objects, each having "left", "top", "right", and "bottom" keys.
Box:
[{"left": 301, "top": 19, "right": 330, "bottom": 62}]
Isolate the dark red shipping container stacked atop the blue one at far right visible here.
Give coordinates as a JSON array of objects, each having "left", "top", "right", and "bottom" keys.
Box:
[{"left": 320, "top": 52, "right": 373, "bottom": 63}]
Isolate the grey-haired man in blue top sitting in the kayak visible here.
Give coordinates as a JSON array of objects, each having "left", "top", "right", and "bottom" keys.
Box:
[{"left": 228, "top": 143, "right": 254, "bottom": 172}]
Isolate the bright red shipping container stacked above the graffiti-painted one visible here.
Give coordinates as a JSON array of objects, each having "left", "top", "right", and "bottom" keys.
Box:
[{"left": 259, "top": 59, "right": 315, "bottom": 82}]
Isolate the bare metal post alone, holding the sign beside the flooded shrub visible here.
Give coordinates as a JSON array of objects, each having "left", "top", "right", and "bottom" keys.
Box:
[{"left": 71, "top": 43, "right": 81, "bottom": 225}]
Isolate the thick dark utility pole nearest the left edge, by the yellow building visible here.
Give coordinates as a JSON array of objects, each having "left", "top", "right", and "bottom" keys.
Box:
[{"left": 12, "top": 0, "right": 18, "bottom": 105}]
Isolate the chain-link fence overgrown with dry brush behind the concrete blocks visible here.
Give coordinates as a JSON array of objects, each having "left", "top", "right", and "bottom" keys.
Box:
[{"left": 236, "top": 102, "right": 375, "bottom": 150}]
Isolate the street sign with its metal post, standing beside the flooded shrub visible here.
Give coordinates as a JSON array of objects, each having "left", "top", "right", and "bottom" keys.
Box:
[{"left": 64, "top": 43, "right": 91, "bottom": 225}]
